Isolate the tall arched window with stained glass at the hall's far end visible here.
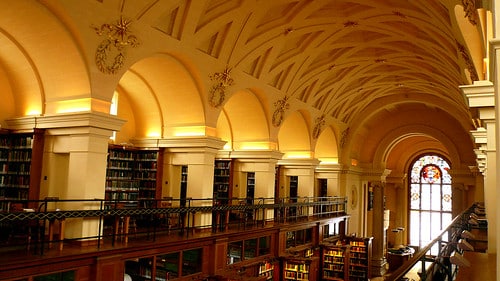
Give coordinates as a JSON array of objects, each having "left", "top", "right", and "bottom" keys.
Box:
[{"left": 410, "top": 155, "right": 452, "bottom": 252}]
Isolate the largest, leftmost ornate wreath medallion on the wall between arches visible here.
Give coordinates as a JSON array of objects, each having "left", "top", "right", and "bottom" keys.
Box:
[{"left": 94, "top": 17, "right": 140, "bottom": 74}]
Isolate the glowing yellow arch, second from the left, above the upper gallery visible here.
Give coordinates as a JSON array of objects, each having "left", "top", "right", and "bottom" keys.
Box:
[{"left": 118, "top": 54, "right": 206, "bottom": 138}]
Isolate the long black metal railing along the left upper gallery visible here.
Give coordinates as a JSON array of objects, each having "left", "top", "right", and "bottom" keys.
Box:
[{"left": 0, "top": 197, "right": 347, "bottom": 254}]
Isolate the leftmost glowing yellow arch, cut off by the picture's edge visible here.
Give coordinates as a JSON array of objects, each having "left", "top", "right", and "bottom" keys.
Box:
[{"left": 0, "top": 1, "right": 89, "bottom": 120}]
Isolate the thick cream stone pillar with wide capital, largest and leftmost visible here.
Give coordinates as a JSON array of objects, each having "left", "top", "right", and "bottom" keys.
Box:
[{"left": 7, "top": 112, "right": 124, "bottom": 243}]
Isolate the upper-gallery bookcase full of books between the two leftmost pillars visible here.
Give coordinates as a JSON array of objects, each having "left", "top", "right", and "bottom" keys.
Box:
[{"left": 105, "top": 146, "right": 161, "bottom": 207}]
